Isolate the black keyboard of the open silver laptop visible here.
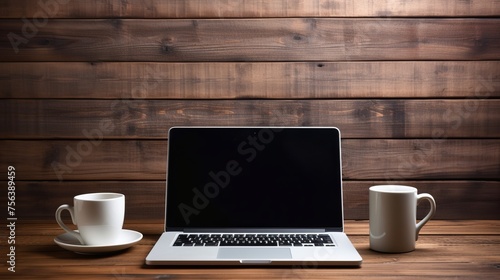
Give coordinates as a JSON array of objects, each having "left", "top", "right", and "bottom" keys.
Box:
[{"left": 174, "top": 234, "right": 335, "bottom": 246}]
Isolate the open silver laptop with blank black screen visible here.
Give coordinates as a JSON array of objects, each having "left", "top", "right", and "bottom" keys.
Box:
[{"left": 145, "top": 127, "right": 362, "bottom": 267}]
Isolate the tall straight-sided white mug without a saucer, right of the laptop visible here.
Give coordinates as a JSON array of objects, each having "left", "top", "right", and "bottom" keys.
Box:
[{"left": 369, "top": 185, "right": 436, "bottom": 253}]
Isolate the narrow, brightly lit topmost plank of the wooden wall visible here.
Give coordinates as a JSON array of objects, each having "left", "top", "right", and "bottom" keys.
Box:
[{"left": 0, "top": 0, "right": 500, "bottom": 19}]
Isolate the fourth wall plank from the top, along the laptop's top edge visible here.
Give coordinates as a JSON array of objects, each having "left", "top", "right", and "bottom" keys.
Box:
[{"left": 0, "top": 99, "right": 500, "bottom": 141}]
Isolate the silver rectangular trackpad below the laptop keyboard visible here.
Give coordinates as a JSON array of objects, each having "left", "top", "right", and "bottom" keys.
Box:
[{"left": 217, "top": 248, "right": 292, "bottom": 260}]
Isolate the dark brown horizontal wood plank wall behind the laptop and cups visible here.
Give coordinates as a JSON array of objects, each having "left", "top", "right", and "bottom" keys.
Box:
[{"left": 0, "top": 0, "right": 500, "bottom": 219}]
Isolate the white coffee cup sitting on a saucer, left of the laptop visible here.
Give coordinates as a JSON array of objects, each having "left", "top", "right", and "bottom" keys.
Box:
[{"left": 56, "top": 193, "right": 125, "bottom": 245}]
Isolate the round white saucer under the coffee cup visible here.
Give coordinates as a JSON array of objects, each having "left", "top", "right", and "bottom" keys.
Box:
[{"left": 54, "top": 229, "right": 142, "bottom": 254}]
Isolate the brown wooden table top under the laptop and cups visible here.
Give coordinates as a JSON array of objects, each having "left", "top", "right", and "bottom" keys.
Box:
[{"left": 4, "top": 220, "right": 500, "bottom": 279}]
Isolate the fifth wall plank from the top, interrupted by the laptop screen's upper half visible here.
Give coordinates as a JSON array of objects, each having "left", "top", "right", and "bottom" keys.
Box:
[{"left": 0, "top": 139, "right": 500, "bottom": 181}]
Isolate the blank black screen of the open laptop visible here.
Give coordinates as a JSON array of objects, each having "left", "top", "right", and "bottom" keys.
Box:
[{"left": 166, "top": 127, "right": 343, "bottom": 230}]
